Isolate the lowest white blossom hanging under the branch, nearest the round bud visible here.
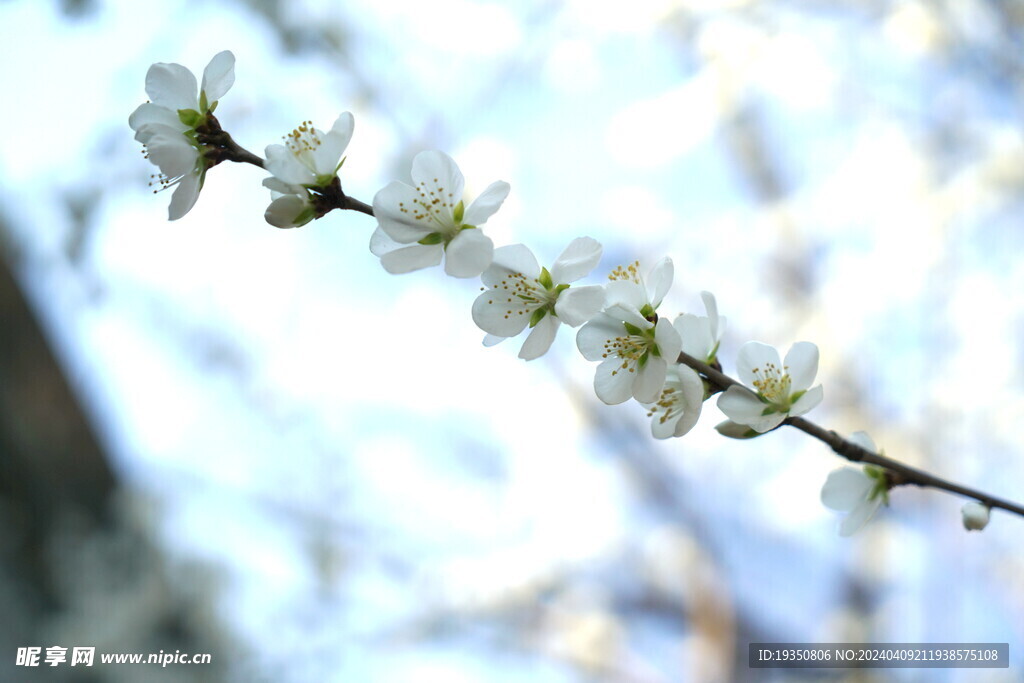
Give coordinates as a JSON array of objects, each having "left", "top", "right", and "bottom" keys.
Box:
[{"left": 821, "top": 432, "right": 889, "bottom": 536}]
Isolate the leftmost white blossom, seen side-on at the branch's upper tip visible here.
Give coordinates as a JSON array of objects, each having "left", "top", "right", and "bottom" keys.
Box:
[{"left": 128, "top": 50, "right": 234, "bottom": 220}]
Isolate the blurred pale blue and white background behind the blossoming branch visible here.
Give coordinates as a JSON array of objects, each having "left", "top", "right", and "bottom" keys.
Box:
[{"left": 0, "top": 0, "right": 1024, "bottom": 683}]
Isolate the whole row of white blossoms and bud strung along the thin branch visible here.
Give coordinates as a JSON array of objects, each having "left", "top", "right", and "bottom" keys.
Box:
[{"left": 129, "top": 51, "right": 988, "bottom": 536}]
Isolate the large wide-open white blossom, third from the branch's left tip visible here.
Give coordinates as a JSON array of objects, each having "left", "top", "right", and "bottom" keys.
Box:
[{"left": 370, "top": 152, "right": 509, "bottom": 278}]
